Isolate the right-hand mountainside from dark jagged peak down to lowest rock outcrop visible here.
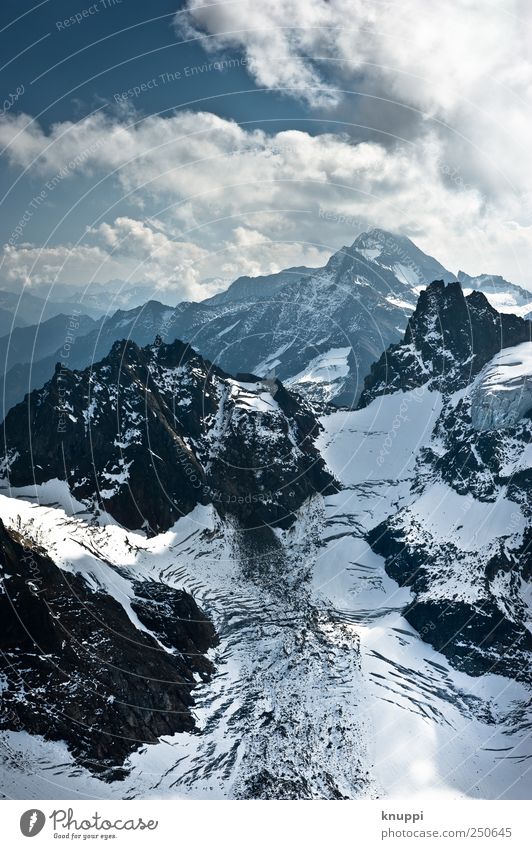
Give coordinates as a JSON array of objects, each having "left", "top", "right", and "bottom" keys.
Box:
[{"left": 360, "top": 283, "right": 532, "bottom": 681}]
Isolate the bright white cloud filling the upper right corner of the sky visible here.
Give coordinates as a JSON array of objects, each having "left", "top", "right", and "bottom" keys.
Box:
[{"left": 182, "top": 0, "right": 532, "bottom": 205}]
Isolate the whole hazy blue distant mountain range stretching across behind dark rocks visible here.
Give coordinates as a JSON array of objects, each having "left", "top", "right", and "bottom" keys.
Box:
[{"left": 0, "top": 229, "right": 532, "bottom": 420}]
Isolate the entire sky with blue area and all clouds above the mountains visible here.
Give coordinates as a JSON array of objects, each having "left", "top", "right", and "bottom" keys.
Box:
[{"left": 0, "top": 0, "right": 532, "bottom": 300}]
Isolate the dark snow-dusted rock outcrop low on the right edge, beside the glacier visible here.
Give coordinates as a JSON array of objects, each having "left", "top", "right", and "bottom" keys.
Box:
[{"left": 367, "top": 509, "right": 532, "bottom": 683}]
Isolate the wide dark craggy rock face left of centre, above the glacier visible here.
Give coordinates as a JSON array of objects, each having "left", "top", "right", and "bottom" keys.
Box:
[{"left": 0, "top": 339, "right": 334, "bottom": 533}]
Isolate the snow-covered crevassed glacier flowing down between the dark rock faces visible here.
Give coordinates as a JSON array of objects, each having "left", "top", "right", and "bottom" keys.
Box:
[{"left": 0, "top": 390, "right": 530, "bottom": 799}]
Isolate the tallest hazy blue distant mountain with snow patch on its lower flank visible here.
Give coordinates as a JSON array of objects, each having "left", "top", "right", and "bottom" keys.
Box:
[{"left": 171, "top": 232, "right": 426, "bottom": 405}]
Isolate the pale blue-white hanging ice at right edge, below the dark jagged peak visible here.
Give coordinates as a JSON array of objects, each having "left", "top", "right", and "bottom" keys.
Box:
[{"left": 471, "top": 342, "right": 532, "bottom": 430}]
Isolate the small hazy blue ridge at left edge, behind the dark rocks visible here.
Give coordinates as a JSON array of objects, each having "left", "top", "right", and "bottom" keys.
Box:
[{"left": 0, "top": 313, "right": 99, "bottom": 373}]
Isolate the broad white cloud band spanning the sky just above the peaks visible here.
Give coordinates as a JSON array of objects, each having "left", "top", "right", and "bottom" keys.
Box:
[{"left": 0, "top": 107, "right": 532, "bottom": 288}]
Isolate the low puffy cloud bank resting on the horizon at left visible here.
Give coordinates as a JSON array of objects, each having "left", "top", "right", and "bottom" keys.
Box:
[{"left": 0, "top": 216, "right": 328, "bottom": 302}]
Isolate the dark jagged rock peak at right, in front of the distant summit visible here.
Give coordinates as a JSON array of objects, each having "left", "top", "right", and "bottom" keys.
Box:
[{"left": 360, "top": 280, "right": 532, "bottom": 406}]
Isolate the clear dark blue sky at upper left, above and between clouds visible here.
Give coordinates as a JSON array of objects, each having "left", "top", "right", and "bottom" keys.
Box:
[{"left": 0, "top": 0, "right": 308, "bottom": 248}]
